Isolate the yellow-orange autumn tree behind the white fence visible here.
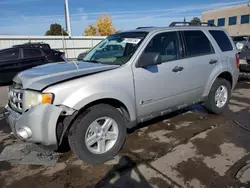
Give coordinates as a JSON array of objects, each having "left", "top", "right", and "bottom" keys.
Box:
[{"left": 84, "top": 14, "right": 116, "bottom": 36}]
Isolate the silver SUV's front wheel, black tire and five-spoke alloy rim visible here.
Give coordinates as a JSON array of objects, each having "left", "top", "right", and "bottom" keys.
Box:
[{"left": 68, "top": 104, "right": 126, "bottom": 163}]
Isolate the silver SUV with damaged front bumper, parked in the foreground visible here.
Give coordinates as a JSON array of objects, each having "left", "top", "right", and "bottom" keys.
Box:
[{"left": 5, "top": 23, "right": 239, "bottom": 163}]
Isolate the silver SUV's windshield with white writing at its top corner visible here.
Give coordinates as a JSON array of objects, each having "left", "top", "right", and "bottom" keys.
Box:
[{"left": 83, "top": 32, "right": 148, "bottom": 65}]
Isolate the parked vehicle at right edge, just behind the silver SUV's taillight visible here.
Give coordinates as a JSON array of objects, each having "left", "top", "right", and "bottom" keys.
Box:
[{"left": 232, "top": 35, "right": 250, "bottom": 73}]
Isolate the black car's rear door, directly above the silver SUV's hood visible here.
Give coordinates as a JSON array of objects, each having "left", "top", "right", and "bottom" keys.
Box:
[{"left": 20, "top": 48, "right": 47, "bottom": 70}]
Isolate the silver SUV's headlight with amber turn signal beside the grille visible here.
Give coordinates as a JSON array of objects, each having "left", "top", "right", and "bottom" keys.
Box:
[{"left": 24, "top": 90, "right": 54, "bottom": 109}]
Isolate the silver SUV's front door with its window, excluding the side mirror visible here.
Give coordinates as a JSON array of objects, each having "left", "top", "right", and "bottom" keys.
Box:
[{"left": 133, "top": 31, "right": 188, "bottom": 121}]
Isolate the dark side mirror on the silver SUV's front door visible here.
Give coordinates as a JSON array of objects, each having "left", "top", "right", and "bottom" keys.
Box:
[{"left": 136, "top": 52, "right": 161, "bottom": 67}]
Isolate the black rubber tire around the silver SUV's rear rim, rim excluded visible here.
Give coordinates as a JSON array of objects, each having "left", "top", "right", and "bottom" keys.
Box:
[{"left": 204, "top": 78, "right": 232, "bottom": 114}]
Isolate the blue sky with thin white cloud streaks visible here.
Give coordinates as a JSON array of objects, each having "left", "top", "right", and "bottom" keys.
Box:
[{"left": 0, "top": 0, "right": 249, "bottom": 36}]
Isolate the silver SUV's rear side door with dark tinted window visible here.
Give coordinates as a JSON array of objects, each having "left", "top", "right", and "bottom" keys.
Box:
[{"left": 182, "top": 30, "right": 220, "bottom": 103}]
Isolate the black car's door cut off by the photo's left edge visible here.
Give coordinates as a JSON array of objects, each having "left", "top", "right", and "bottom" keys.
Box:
[{"left": 0, "top": 48, "right": 20, "bottom": 82}]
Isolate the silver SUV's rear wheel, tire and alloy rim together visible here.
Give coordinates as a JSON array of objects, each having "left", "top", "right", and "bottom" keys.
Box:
[{"left": 204, "top": 78, "right": 231, "bottom": 114}]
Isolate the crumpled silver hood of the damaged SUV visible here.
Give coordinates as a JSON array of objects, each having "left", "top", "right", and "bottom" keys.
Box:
[{"left": 13, "top": 61, "right": 119, "bottom": 90}]
